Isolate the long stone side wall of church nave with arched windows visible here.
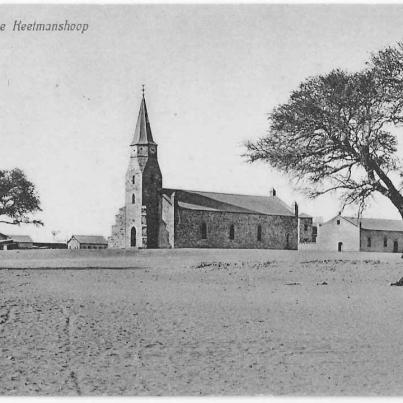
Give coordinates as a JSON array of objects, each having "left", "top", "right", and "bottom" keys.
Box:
[{"left": 175, "top": 208, "right": 298, "bottom": 249}]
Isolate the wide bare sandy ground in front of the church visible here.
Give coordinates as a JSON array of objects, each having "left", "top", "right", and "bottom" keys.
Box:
[{"left": 0, "top": 250, "right": 403, "bottom": 395}]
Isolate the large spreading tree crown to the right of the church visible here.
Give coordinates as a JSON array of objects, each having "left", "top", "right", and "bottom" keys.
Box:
[{"left": 246, "top": 44, "right": 403, "bottom": 217}]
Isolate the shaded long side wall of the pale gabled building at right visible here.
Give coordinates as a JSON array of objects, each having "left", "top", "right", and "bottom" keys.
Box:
[{"left": 360, "top": 229, "right": 403, "bottom": 253}]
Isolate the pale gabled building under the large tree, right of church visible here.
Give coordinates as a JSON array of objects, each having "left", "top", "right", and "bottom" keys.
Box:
[{"left": 317, "top": 215, "right": 403, "bottom": 253}]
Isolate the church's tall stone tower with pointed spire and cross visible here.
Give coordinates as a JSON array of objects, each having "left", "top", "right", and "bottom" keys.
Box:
[{"left": 123, "top": 92, "right": 162, "bottom": 248}]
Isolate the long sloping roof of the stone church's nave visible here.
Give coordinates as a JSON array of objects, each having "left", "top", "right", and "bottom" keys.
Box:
[{"left": 163, "top": 189, "right": 309, "bottom": 217}]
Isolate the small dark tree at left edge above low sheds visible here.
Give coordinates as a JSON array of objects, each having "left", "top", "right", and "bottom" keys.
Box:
[{"left": 0, "top": 169, "right": 43, "bottom": 225}]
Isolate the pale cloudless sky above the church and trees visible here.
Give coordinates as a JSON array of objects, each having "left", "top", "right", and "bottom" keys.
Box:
[{"left": 0, "top": 4, "right": 403, "bottom": 241}]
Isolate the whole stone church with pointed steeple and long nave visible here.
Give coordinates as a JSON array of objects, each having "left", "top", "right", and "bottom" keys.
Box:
[{"left": 108, "top": 94, "right": 312, "bottom": 249}]
